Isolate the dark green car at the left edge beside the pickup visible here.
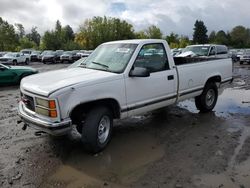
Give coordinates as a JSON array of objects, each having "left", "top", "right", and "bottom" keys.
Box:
[{"left": 0, "top": 63, "right": 38, "bottom": 85}]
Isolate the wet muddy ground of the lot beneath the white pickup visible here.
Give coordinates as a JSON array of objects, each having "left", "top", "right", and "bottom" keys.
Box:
[{"left": 0, "top": 63, "right": 250, "bottom": 188}]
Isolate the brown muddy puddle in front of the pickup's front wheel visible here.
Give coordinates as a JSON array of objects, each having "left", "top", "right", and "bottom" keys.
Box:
[{"left": 49, "top": 131, "right": 164, "bottom": 187}]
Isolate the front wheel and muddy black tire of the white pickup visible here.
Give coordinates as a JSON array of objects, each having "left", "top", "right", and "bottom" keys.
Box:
[{"left": 82, "top": 106, "right": 113, "bottom": 153}]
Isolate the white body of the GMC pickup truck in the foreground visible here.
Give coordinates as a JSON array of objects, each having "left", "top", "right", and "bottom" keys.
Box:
[{"left": 19, "top": 39, "right": 232, "bottom": 152}]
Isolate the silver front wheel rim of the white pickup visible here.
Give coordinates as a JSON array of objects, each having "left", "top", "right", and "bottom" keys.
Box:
[{"left": 98, "top": 116, "right": 110, "bottom": 144}]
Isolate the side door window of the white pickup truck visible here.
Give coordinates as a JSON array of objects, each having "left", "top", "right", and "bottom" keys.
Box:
[{"left": 134, "top": 43, "right": 169, "bottom": 73}]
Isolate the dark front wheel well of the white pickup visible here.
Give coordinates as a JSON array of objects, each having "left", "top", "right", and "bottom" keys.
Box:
[{"left": 70, "top": 99, "right": 120, "bottom": 124}]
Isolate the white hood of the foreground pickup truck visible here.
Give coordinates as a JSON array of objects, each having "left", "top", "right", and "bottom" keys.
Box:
[{"left": 21, "top": 68, "right": 117, "bottom": 97}]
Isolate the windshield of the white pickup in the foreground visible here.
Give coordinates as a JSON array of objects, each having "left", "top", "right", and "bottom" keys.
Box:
[{"left": 85, "top": 43, "right": 137, "bottom": 73}]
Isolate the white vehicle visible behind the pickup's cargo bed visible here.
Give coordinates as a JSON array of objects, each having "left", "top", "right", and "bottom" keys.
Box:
[{"left": 176, "top": 44, "right": 229, "bottom": 58}]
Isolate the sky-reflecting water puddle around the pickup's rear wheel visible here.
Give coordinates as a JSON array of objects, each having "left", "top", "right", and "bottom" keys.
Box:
[{"left": 178, "top": 88, "right": 250, "bottom": 117}]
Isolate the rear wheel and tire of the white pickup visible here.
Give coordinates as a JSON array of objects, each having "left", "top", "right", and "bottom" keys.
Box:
[{"left": 195, "top": 82, "right": 218, "bottom": 112}]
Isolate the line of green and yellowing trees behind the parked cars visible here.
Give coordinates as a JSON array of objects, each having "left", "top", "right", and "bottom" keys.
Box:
[{"left": 0, "top": 16, "right": 250, "bottom": 51}]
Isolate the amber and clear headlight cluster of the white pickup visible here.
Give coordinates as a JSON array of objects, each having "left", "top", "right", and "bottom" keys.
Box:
[{"left": 36, "top": 98, "right": 57, "bottom": 118}]
